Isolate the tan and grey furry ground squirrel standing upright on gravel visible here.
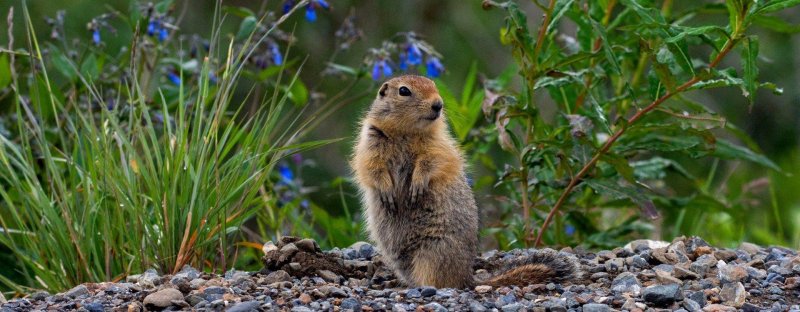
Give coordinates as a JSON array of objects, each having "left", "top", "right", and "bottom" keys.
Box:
[{"left": 351, "top": 76, "right": 580, "bottom": 288}]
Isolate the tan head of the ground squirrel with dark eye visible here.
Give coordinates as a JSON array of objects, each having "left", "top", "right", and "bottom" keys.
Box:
[{"left": 369, "top": 75, "right": 444, "bottom": 130}]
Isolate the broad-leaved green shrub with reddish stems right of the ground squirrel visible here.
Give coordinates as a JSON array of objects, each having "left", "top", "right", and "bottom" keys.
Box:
[{"left": 483, "top": 0, "right": 797, "bottom": 246}]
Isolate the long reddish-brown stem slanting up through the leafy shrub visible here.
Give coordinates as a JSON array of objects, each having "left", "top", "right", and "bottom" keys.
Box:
[{"left": 533, "top": 38, "right": 736, "bottom": 247}]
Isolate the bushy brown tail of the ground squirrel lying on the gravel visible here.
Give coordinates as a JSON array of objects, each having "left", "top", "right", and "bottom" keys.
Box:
[{"left": 479, "top": 249, "right": 581, "bottom": 287}]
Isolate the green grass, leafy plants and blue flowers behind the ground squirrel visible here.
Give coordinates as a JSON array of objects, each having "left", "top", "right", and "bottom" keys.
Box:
[{"left": 0, "top": 0, "right": 800, "bottom": 291}]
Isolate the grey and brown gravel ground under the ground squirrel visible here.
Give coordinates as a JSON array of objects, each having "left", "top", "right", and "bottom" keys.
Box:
[{"left": 0, "top": 237, "right": 800, "bottom": 312}]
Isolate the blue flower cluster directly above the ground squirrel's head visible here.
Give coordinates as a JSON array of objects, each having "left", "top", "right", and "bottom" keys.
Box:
[{"left": 366, "top": 32, "right": 444, "bottom": 81}]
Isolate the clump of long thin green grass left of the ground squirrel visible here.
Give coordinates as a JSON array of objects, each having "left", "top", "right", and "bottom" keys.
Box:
[{"left": 0, "top": 1, "right": 330, "bottom": 291}]
